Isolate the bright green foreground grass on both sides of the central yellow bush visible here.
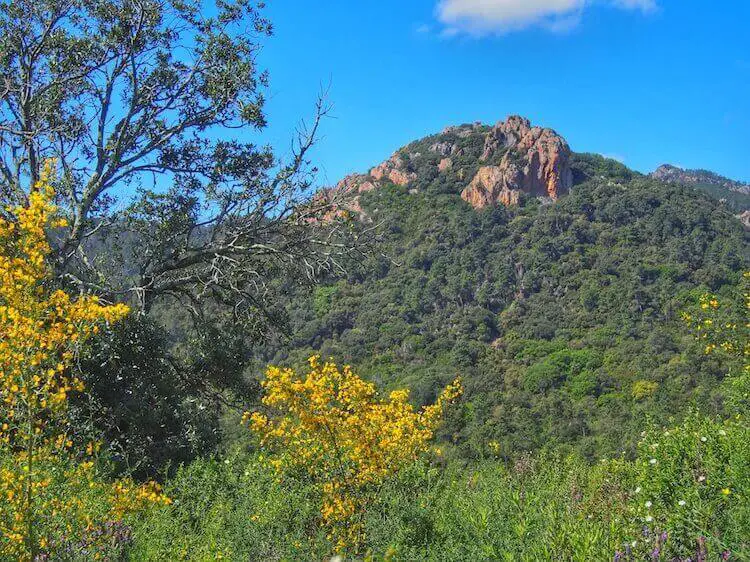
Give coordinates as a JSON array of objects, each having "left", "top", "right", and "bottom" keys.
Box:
[{"left": 129, "top": 415, "right": 750, "bottom": 561}]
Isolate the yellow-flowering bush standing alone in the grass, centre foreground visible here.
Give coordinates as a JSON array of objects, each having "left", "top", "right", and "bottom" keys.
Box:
[{"left": 244, "top": 356, "right": 463, "bottom": 550}]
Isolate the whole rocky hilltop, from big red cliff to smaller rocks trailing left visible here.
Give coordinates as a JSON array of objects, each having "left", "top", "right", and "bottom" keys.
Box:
[{"left": 319, "top": 115, "right": 573, "bottom": 217}]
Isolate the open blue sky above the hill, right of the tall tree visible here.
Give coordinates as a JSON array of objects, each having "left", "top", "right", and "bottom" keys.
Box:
[{"left": 254, "top": 0, "right": 750, "bottom": 183}]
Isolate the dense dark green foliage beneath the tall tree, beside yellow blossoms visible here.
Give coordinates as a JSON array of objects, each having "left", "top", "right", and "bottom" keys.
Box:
[{"left": 71, "top": 315, "right": 221, "bottom": 478}]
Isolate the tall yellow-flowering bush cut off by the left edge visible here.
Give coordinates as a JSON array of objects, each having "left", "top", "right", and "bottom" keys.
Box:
[{"left": 0, "top": 163, "right": 167, "bottom": 560}]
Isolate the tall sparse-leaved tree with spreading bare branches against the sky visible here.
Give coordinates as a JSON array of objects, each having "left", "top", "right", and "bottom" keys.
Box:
[{"left": 0, "top": 0, "right": 362, "bottom": 319}]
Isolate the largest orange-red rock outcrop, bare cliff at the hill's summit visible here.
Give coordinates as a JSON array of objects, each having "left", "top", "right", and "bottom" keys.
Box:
[{"left": 461, "top": 116, "right": 573, "bottom": 208}]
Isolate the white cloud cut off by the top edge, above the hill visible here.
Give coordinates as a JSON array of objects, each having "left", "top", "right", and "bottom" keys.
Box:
[{"left": 437, "top": 0, "right": 656, "bottom": 35}]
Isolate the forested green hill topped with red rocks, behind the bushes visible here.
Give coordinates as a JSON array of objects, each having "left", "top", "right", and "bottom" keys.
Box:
[{"left": 259, "top": 112, "right": 750, "bottom": 458}]
